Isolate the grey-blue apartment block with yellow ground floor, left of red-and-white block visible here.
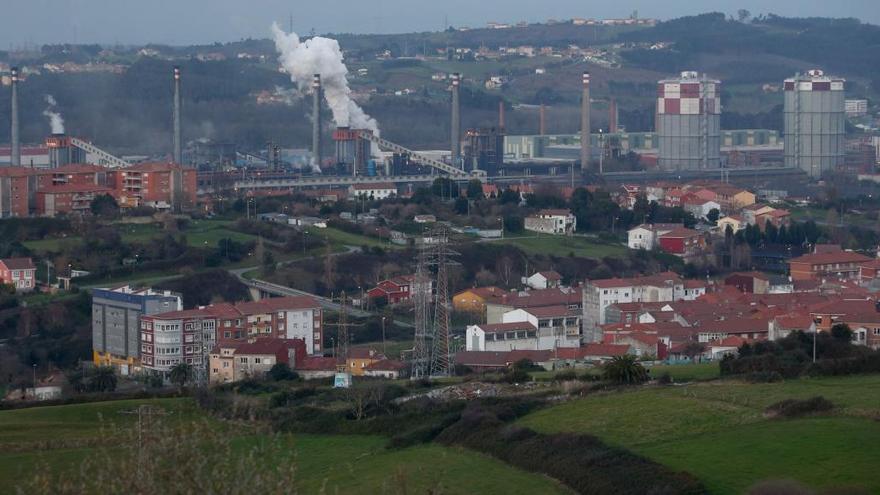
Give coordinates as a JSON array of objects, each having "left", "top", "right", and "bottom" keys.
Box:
[{"left": 92, "top": 285, "right": 183, "bottom": 375}]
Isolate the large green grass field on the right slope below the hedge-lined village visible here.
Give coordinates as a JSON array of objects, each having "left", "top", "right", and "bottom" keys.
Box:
[{"left": 521, "top": 375, "right": 880, "bottom": 494}]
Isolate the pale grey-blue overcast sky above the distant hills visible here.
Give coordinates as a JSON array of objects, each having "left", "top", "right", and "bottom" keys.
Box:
[{"left": 0, "top": 0, "right": 880, "bottom": 48}]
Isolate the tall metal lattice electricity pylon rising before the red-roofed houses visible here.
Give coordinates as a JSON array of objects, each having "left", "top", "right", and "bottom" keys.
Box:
[{"left": 411, "top": 225, "right": 458, "bottom": 380}]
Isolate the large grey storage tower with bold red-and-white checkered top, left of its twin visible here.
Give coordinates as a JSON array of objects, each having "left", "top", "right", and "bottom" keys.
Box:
[{"left": 656, "top": 72, "right": 721, "bottom": 170}]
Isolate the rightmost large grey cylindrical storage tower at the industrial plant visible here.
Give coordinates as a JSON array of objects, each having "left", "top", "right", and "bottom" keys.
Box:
[{"left": 785, "top": 69, "right": 846, "bottom": 179}]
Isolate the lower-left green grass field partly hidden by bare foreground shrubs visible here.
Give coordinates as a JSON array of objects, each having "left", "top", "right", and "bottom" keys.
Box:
[{"left": 0, "top": 399, "right": 568, "bottom": 494}]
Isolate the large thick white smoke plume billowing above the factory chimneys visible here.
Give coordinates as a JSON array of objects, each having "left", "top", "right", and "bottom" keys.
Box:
[{"left": 272, "top": 23, "right": 379, "bottom": 135}]
